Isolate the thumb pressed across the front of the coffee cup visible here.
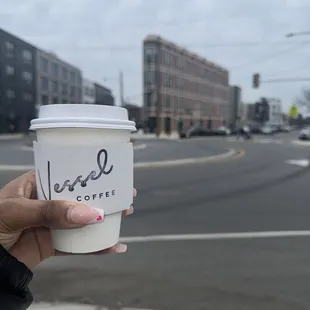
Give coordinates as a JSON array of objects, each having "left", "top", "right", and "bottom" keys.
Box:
[{"left": 0, "top": 198, "right": 103, "bottom": 230}]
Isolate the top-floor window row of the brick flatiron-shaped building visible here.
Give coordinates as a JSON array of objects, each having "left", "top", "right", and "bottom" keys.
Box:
[{"left": 144, "top": 46, "right": 228, "bottom": 85}]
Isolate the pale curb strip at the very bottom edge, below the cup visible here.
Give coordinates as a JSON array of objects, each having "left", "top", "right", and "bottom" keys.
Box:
[{"left": 28, "top": 303, "right": 151, "bottom": 310}]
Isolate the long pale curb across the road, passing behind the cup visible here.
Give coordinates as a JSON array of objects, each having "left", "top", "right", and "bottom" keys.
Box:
[{"left": 0, "top": 149, "right": 239, "bottom": 172}]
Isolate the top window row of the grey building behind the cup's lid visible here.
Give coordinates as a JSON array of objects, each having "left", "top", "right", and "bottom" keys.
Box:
[{"left": 40, "top": 57, "right": 82, "bottom": 85}]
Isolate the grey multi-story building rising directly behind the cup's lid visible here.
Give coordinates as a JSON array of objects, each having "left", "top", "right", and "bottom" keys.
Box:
[{"left": 36, "top": 49, "right": 82, "bottom": 105}]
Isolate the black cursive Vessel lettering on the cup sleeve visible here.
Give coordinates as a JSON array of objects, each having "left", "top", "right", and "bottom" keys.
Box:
[{"left": 38, "top": 149, "right": 114, "bottom": 200}]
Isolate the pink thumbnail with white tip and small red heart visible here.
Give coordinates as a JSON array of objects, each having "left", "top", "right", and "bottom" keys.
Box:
[{"left": 68, "top": 206, "right": 104, "bottom": 224}]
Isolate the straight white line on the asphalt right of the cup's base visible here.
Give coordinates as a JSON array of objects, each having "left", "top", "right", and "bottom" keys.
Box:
[{"left": 120, "top": 230, "right": 310, "bottom": 243}]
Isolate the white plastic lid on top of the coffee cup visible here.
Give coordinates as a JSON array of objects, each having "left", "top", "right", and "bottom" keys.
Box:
[{"left": 30, "top": 104, "right": 136, "bottom": 131}]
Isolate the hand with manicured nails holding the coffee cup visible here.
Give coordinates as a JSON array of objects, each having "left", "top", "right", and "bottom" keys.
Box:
[{"left": 0, "top": 171, "right": 137, "bottom": 269}]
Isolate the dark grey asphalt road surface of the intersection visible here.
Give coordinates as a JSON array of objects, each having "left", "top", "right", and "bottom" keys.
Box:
[{"left": 0, "top": 133, "right": 310, "bottom": 310}]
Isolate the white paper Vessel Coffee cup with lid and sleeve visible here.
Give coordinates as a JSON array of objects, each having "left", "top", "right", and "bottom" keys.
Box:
[{"left": 30, "top": 104, "right": 136, "bottom": 253}]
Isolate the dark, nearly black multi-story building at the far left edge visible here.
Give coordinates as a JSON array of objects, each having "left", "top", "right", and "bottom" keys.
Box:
[{"left": 0, "top": 29, "right": 36, "bottom": 133}]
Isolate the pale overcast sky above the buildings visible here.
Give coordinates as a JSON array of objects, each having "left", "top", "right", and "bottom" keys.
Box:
[{"left": 0, "top": 0, "right": 310, "bottom": 110}]
